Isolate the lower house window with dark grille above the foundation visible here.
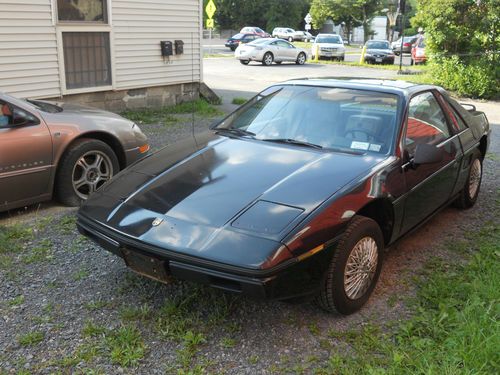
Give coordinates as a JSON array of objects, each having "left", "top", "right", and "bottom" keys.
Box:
[{"left": 62, "top": 32, "right": 111, "bottom": 89}]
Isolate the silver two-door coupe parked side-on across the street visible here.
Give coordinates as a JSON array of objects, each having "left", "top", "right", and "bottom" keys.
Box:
[{"left": 234, "top": 38, "right": 307, "bottom": 65}]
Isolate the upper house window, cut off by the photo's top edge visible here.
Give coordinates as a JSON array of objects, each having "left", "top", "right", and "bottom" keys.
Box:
[{"left": 57, "top": 0, "right": 108, "bottom": 23}]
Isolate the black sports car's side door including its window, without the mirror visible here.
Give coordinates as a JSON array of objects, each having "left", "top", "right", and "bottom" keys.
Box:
[{"left": 402, "top": 91, "right": 462, "bottom": 232}]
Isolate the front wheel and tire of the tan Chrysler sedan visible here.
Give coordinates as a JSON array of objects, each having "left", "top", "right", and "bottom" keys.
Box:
[{"left": 55, "top": 139, "right": 120, "bottom": 206}]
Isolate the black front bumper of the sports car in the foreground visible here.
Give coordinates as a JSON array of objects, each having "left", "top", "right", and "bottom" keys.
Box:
[{"left": 77, "top": 214, "right": 332, "bottom": 299}]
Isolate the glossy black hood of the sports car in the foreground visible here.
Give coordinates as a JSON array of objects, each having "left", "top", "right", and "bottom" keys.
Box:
[{"left": 80, "top": 136, "right": 382, "bottom": 268}]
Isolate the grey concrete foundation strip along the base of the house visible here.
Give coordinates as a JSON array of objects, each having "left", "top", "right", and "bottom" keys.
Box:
[{"left": 48, "top": 82, "right": 200, "bottom": 112}]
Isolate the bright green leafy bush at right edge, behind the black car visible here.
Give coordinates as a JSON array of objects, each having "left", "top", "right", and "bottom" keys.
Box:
[{"left": 429, "top": 55, "right": 500, "bottom": 99}]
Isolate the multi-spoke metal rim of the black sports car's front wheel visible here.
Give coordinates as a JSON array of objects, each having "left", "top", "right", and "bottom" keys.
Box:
[{"left": 344, "top": 237, "right": 378, "bottom": 300}]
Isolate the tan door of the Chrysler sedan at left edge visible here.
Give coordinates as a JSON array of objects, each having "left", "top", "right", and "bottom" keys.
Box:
[{"left": 0, "top": 100, "right": 53, "bottom": 208}]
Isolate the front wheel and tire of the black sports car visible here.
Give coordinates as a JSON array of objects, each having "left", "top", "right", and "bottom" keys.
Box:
[{"left": 316, "top": 216, "right": 384, "bottom": 315}]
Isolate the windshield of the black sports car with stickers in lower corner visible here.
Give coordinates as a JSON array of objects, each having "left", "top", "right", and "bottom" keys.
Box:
[{"left": 215, "top": 85, "right": 398, "bottom": 154}]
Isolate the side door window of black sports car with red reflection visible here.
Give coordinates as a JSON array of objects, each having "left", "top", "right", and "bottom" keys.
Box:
[{"left": 405, "top": 92, "right": 450, "bottom": 155}]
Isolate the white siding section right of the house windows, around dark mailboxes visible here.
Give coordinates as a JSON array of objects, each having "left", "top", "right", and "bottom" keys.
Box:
[{"left": 112, "top": 0, "right": 202, "bottom": 90}]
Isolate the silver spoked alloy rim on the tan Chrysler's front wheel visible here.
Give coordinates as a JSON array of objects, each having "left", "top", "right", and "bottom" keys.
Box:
[{"left": 71, "top": 150, "right": 113, "bottom": 199}]
